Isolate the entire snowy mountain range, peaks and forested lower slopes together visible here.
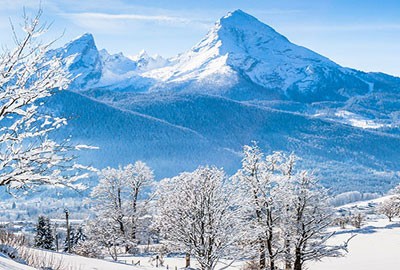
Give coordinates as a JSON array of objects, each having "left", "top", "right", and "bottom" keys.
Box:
[{"left": 39, "top": 10, "right": 400, "bottom": 192}]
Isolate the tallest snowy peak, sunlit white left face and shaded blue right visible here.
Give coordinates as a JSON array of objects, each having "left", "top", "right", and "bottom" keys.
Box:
[{"left": 144, "top": 10, "right": 396, "bottom": 102}]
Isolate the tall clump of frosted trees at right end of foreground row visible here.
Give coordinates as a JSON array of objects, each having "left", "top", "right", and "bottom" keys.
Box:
[{"left": 233, "top": 143, "right": 347, "bottom": 270}]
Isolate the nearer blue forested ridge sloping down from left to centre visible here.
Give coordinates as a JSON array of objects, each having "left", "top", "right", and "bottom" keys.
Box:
[{"left": 47, "top": 91, "right": 238, "bottom": 177}]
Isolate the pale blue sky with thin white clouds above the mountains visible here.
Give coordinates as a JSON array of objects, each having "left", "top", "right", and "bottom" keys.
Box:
[{"left": 0, "top": 0, "right": 400, "bottom": 76}]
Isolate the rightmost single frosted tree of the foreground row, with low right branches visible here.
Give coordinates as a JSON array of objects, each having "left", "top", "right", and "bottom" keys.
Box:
[{"left": 285, "top": 171, "right": 348, "bottom": 270}]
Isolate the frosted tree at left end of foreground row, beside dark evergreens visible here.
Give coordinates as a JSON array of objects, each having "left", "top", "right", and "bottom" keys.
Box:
[{"left": 90, "top": 161, "right": 154, "bottom": 253}]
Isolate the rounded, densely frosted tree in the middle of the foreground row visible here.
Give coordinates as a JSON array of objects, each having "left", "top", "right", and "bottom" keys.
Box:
[{"left": 157, "top": 167, "right": 239, "bottom": 269}]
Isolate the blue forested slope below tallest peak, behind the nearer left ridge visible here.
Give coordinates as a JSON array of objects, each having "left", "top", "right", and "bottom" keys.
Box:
[{"left": 79, "top": 92, "right": 400, "bottom": 193}]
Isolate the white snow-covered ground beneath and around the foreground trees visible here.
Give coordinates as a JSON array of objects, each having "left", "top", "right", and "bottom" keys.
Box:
[{"left": 0, "top": 197, "right": 400, "bottom": 270}]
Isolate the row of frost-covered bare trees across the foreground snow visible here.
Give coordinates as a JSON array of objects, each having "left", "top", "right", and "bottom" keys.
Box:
[{"left": 36, "top": 143, "right": 347, "bottom": 270}]
